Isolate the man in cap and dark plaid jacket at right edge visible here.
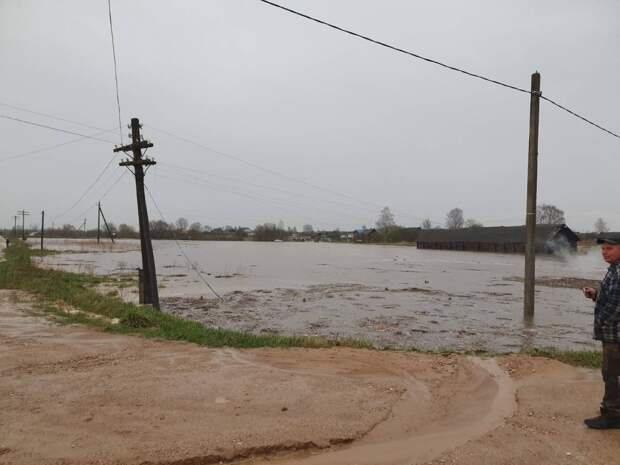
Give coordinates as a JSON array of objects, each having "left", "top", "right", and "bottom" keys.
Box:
[{"left": 583, "top": 234, "right": 620, "bottom": 429}]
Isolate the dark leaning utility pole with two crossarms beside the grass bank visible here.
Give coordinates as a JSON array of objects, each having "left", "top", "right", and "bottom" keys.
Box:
[{"left": 114, "top": 118, "right": 159, "bottom": 310}]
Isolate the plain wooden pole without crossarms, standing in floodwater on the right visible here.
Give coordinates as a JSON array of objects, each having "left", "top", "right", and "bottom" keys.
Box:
[{"left": 523, "top": 72, "right": 540, "bottom": 320}]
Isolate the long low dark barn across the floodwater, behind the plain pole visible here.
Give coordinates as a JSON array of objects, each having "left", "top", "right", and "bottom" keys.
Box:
[{"left": 417, "top": 224, "right": 579, "bottom": 253}]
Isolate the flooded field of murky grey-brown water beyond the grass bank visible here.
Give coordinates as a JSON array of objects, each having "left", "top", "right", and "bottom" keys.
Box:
[{"left": 35, "top": 240, "right": 606, "bottom": 352}]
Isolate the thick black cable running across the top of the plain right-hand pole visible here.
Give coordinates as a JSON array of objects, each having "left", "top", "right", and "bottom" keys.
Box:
[{"left": 258, "top": 0, "right": 620, "bottom": 139}]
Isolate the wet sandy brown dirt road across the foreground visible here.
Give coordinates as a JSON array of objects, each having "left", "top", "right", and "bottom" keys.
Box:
[{"left": 0, "top": 291, "right": 620, "bottom": 465}]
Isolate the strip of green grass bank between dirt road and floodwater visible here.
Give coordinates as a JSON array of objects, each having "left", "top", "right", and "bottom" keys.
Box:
[{"left": 0, "top": 243, "right": 601, "bottom": 368}]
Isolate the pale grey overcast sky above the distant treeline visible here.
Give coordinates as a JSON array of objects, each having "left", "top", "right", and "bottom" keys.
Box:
[{"left": 0, "top": 0, "right": 620, "bottom": 230}]
